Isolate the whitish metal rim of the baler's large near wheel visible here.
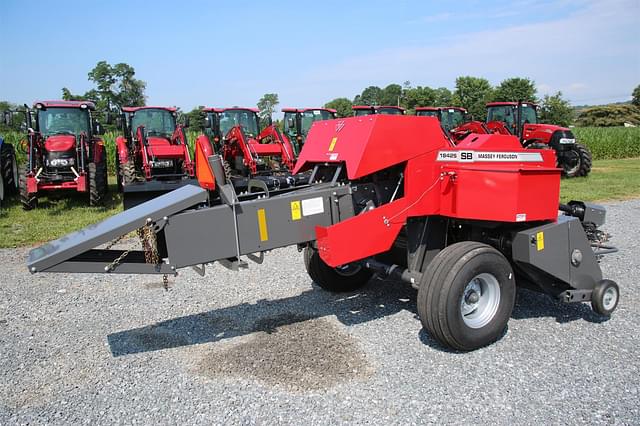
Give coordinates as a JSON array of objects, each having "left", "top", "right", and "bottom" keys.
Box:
[{"left": 460, "top": 273, "right": 500, "bottom": 328}]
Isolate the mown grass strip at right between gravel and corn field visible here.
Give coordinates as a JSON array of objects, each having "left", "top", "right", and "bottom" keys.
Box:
[{"left": 560, "top": 158, "right": 640, "bottom": 202}]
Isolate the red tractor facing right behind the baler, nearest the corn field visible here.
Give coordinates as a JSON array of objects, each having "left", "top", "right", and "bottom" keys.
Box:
[{"left": 452, "top": 102, "right": 591, "bottom": 177}]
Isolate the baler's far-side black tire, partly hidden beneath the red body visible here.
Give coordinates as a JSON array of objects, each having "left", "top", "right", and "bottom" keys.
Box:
[{"left": 304, "top": 246, "right": 373, "bottom": 293}]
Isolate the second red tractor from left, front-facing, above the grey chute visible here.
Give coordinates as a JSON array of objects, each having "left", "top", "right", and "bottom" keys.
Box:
[{"left": 116, "top": 106, "right": 195, "bottom": 209}]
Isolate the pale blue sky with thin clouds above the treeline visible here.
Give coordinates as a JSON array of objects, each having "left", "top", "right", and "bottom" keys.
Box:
[{"left": 0, "top": 0, "right": 640, "bottom": 110}]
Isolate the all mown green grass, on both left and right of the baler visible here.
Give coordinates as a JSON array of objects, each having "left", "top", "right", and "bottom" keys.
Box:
[{"left": 0, "top": 158, "right": 640, "bottom": 247}]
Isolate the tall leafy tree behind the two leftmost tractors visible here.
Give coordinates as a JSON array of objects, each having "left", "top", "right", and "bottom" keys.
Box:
[{"left": 62, "top": 61, "right": 147, "bottom": 111}]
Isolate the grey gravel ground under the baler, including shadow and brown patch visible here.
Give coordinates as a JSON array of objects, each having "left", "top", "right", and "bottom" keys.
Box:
[{"left": 0, "top": 200, "right": 640, "bottom": 424}]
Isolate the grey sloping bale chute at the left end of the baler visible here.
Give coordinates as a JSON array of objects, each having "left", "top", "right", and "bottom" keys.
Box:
[{"left": 27, "top": 185, "right": 208, "bottom": 273}]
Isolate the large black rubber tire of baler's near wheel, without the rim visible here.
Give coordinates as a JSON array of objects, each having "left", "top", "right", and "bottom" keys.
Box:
[{"left": 417, "top": 241, "right": 516, "bottom": 351}]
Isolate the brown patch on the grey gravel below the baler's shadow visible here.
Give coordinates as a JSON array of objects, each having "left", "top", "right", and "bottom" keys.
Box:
[{"left": 195, "top": 315, "right": 373, "bottom": 392}]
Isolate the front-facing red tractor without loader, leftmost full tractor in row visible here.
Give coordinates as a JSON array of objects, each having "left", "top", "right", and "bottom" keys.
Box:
[{"left": 18, "top": 101, "right": 107, "bottom": 210}]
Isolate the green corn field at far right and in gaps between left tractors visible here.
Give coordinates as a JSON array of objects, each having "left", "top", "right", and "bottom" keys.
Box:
[{"left": 4, "top": 127, "right": 640, "bottom": 175}]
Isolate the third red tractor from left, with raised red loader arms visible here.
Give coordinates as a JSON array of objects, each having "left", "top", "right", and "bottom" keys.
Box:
[{"left": 198, "top": 107, "right": 304, "bottom": 192}]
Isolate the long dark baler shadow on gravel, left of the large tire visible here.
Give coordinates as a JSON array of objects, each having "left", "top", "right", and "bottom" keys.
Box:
[{"left": 107, "top": 279, "right": 416, "bottom": 357}]
